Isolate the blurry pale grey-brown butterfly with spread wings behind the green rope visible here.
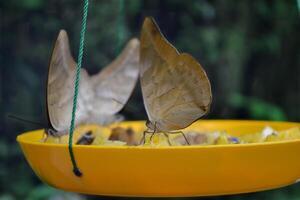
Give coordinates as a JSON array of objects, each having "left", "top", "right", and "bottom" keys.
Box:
[{"left": 46, "top": 30, "right": 139, "bottom": 137}]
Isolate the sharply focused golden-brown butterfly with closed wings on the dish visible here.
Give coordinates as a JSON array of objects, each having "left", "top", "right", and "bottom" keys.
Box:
[{"left": 140, "top": 17, "right": 212, "bottom": 142}]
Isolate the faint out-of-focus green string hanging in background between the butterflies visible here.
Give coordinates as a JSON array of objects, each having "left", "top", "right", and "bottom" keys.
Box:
[{"left": 116, "top": 0, "right": 125, "bottom": 55}]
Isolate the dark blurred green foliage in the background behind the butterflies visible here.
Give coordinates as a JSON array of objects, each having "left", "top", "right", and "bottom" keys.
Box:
[{"left": 0, "top": 0, "right": 300, "bottom": 200}]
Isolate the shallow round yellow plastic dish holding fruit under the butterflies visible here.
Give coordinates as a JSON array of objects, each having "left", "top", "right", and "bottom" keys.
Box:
[{"left": 17, "top": 120, "right": 300, "bottom": 197}]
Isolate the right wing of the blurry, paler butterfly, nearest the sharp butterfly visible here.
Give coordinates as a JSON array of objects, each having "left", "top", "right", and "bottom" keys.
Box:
[{"left": 91, "top": 39, "right": 139, "bottom": 123}]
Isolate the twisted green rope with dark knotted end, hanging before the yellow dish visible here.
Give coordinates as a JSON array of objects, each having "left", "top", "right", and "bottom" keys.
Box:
[{"left": 69, "top": 0, "right": 89, "bottom": 176}]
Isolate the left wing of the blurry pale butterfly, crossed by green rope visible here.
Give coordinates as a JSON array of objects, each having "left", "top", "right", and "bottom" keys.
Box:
[{"left": 46, "top": 30, "right": 90, "bottom": 134}]
